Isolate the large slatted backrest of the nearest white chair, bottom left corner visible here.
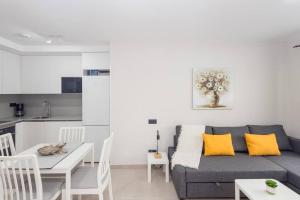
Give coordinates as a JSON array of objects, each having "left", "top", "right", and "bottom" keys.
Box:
[{"left": 0, "top": 155, "right": 43, "bottom": 200}]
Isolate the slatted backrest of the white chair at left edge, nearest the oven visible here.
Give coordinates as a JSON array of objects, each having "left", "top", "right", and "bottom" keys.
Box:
[{"left": 0, "top": 133, "right": 16, "bottom": 156}]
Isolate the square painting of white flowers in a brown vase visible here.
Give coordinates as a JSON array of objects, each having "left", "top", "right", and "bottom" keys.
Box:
[{"left": 193, "top": 69, "right": 233, "bottom": 110}]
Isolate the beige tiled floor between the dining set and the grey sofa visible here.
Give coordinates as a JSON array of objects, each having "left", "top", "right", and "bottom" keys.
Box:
[{"left": 69, "top": 168, "right": 231, "bottom": 200}]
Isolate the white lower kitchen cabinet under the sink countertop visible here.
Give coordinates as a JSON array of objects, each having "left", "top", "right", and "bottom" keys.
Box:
[{"left": 16, "top": 121, "right": 82, "bottom": 153}]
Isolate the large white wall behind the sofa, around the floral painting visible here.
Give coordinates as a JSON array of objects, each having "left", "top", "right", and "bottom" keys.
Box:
[{"left": 111, "top": 41, "right": 277, "bottom": 164}]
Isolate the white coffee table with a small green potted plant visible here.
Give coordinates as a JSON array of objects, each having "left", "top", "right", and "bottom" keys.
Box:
[{"left": 235, "top": 179, "right": 300, "bottom": 200}]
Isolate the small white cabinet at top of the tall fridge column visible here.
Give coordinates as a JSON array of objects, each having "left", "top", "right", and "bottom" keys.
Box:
[{"left": 82, "top": 52, "right": 110, "bottom": 69}]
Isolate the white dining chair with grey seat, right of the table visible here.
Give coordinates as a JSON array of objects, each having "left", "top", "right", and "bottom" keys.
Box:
[{"left": 62, "top": 133, "right": 114, "bottom": 200}]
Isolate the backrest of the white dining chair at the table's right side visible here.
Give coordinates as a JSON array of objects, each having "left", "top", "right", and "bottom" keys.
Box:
[{"left": 97, "top": 133, "right": 114, "bottom": 187}]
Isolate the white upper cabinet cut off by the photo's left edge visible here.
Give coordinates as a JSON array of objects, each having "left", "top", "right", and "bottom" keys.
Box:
[{"left": 0, "top": 51, "right": 21, "bottom": 94}]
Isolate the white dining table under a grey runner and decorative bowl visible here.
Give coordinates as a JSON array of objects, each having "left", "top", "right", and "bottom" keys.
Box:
[{"left": 18, "top": 143, "right": 95, "bottom": 200}]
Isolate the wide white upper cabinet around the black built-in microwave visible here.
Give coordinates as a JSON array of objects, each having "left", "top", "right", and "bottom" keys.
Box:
[{"left": 21, "top": 56, "right": 82, "bottom": 94}]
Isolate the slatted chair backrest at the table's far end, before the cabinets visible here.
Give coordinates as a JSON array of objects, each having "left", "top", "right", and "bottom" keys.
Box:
[{"left": 59, "top": 127, "right": 85, "bottom": 143}]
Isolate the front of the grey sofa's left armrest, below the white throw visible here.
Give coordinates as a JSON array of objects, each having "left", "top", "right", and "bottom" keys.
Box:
[{"left": 172, "top": 165, "right": 187, "bottom": 199}]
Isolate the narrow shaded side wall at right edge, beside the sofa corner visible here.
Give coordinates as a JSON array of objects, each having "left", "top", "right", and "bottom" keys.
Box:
[{"left": 277, "top": 45, "right": 300, "bottom": 138}]
